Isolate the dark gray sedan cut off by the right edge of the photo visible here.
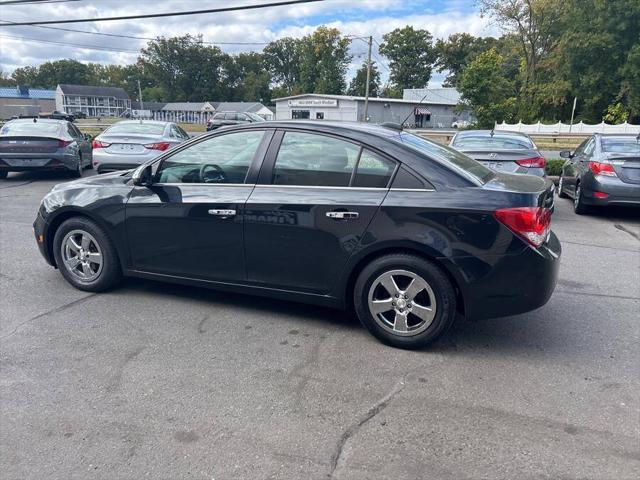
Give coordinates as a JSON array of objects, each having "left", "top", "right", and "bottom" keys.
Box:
[{"left": 558, "top": 134, "right": 640, "bottom": 213}]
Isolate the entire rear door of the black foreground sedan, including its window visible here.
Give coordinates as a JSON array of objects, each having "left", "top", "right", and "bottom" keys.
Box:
[{"left": 245, "top": 130, "right": 396, "bottom": 294}]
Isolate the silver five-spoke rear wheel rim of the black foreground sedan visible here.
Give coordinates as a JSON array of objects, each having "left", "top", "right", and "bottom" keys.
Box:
[{"left": 368, "top": 270, "right": 437, "bottom": 336}]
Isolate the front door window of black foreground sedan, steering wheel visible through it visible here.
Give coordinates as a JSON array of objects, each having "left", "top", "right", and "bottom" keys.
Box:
[{"left": 157, "top": 131, "right": 264, "bottom": 183}]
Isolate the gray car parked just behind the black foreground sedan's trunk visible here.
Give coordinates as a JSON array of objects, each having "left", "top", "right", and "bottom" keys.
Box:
[{"left": 450, "top": 130, "right": 545, "bottom": 177}]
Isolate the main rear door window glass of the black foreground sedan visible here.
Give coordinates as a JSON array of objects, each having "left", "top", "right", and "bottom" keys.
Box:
[{"left": 273, "top": 132, "right": 360, "bottom": 187}]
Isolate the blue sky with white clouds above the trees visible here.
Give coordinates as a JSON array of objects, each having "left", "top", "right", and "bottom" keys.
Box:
[{"left": 0, "top": 0, "right": 499, "bottom": 87}]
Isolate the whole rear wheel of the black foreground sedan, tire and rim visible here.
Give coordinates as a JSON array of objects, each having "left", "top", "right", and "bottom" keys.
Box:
[{"left": 354, "top": 254, "right": 456, "bottom": 349}]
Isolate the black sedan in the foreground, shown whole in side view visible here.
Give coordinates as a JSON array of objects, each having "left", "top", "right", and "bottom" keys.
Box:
[{"left": 34, "top": 121, "right": 560, "bottom": 348}]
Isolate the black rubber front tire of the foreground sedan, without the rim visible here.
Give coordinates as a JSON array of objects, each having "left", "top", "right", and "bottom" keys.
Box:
[{"left": 53, "top": 217, "right": 122, "bottom": 292}]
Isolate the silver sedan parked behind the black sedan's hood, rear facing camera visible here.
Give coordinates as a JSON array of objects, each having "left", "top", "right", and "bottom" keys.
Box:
[{"left": 93, "top": 120, "right": 189, "bottom": 173}]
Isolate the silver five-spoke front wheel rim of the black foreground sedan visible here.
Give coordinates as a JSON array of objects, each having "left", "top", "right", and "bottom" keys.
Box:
[{"left": 60, "top": 230, "right": 102, "bottom": 282}]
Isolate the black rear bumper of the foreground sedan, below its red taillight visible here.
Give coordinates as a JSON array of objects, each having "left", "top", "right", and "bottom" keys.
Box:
[{"left": 456, "top": 232, "right": 562, "bottom": 320}]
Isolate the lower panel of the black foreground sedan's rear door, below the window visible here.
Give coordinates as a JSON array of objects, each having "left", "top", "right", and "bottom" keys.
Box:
[{"left": 245, "top": 185, "right": 387, "bottom": 293}]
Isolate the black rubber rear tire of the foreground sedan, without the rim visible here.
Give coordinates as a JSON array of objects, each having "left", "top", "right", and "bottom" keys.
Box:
[{"left": 353, "top": 254, "right": 456, "bottom": 349}]
